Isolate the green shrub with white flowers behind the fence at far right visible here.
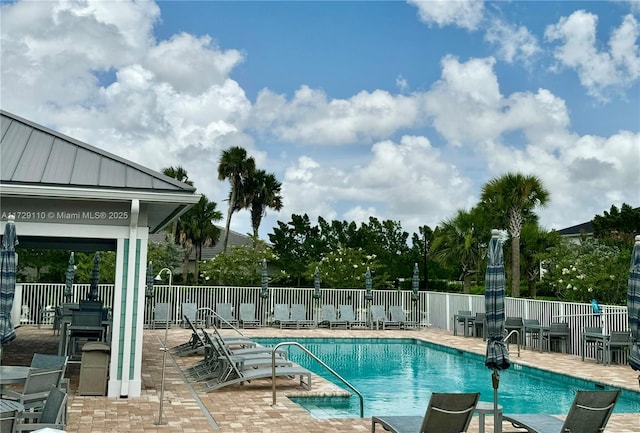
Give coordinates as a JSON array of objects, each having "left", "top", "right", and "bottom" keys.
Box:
[{"left": 541, "top": 239, "right": 630, "bottom": 304}]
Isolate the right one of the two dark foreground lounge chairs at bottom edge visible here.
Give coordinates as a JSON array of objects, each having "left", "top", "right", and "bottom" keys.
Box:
[{"left": 502, "top": 390, "right": 620, "bottom": 433}]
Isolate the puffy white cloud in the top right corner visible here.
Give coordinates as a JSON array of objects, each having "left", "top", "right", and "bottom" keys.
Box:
[{"left": 545, "top": 10, "right": 640, "bottom": 97}]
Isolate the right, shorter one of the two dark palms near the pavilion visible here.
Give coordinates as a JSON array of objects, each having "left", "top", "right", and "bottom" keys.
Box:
[{"left": 247, "top": 170, "right": 283, "bottom": 239}]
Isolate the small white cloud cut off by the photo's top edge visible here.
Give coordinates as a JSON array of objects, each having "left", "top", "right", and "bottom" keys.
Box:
[{"left": 407, "top": 0, "right": 484, "bottom": 30}]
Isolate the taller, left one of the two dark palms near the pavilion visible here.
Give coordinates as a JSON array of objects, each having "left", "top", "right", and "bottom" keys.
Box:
[{"left": 218, "top": 146, "right": 256, "bottom": 252}]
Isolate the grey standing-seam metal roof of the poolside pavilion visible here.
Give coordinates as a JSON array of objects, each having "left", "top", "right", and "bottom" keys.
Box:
[{"left": 0, "top": 110, "right": 195, "bottom": 192}]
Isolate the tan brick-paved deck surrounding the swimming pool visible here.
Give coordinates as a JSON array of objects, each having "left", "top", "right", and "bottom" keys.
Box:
[{"left": 2, "top": 327, "right": 640, "bottom": 433}]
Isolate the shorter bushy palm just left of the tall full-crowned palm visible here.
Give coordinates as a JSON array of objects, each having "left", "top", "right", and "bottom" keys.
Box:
[{"left": 429, "top": 210, "right": 486, "bottom": 293}]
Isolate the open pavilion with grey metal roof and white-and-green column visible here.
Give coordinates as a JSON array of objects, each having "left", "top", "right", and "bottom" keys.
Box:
[{"left": 0, "top": 110, "right": 200, "bottom": 397}]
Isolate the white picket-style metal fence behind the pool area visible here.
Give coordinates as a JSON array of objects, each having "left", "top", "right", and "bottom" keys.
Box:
[{"left": 16, "top": 283, "right": 628, "bottom": 357}]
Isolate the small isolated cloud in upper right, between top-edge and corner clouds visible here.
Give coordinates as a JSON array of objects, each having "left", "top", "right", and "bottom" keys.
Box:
[{"left": 484, "top": 19, "right": 542, "bottom": 63}]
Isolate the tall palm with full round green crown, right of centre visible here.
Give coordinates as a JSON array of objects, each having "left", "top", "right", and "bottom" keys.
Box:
[{"left": 480, "top": 173, "right": 549, "bottom": 297}]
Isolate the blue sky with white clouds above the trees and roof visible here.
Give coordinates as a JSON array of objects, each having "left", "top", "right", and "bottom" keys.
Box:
[{"left": 0, "top": 1, "right": 640, "bottom": 237}]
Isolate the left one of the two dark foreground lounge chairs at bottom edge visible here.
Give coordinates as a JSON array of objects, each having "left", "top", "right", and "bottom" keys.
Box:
[{"left": 371, "top": 392, "right": 480, "bottom": 433}]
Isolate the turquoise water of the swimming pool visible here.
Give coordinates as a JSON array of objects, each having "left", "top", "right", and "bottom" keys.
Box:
[{"left": 256, "top": 338, "right": 640, "bottom": 418}]
